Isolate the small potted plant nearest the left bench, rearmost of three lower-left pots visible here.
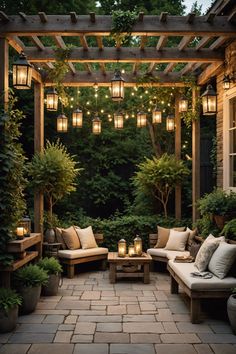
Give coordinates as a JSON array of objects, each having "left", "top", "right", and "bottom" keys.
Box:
[{"left": 38, "top": 257, "right": 62, "bottom": 296}]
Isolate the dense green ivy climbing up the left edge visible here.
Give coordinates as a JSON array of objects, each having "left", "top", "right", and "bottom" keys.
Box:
[{"left": 0, "top": 94, "right": 26, "bottom": 265}]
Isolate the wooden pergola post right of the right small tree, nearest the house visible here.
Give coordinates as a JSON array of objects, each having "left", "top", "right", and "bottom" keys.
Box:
[{"left": 192, "top": 87, "right": 200, "bottom": 222}]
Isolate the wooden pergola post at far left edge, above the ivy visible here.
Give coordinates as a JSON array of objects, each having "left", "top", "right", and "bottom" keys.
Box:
[{"left": 0, "top": 37, "right": 9, "bottom": 109}]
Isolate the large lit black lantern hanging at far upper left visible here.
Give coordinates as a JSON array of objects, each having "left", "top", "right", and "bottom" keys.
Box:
[{"left": 12, "top": 52, "right": 32, "bottom": 90}]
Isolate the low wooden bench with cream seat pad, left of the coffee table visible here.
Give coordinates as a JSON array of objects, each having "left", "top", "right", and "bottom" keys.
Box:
[{"left": 58, "top": 234, "right": 108, "bottom": 278}]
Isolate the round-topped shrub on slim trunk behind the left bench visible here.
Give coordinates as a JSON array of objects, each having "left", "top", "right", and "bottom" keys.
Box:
[{"left": 28, "top": 141, "right": 81, "bottom": 242}]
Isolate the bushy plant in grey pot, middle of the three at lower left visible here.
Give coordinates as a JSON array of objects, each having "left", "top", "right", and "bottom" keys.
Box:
[{"left": 15, "top": 264, "right": 48, "bottom": 314}]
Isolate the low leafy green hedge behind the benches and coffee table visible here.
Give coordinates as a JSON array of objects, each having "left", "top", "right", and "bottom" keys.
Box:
[{"left": 61, "top": 215, "right": 191, "bottom": 251}]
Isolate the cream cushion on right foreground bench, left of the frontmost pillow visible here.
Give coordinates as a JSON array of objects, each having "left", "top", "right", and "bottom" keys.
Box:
[{"left": 195, "top": 234, "right": 225, "bottom": 272}]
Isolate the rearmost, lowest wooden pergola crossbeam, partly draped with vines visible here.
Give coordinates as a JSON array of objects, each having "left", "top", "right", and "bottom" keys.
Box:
[{"left": 45, "top": 71, "right": 190, "bottom": 87}]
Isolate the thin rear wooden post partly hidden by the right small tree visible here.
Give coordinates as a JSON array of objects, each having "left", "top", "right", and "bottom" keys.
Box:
[{"left": 175, "top": 94, "right": 181, "bottom": 219}]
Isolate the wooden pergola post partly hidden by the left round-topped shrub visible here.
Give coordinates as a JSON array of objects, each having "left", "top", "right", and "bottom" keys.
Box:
[{"left": 34, "top": 82, "right": 44, "bottom": 234}]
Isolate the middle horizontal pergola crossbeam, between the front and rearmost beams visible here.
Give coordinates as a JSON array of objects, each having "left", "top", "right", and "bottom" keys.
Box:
[{"left": 25, "top": 47, "right": 224, "bottom": 63}]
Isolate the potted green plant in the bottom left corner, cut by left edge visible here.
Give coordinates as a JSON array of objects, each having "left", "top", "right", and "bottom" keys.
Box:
[{"left": 0, "top": 288, "right": 22, "bottom": 333}]
